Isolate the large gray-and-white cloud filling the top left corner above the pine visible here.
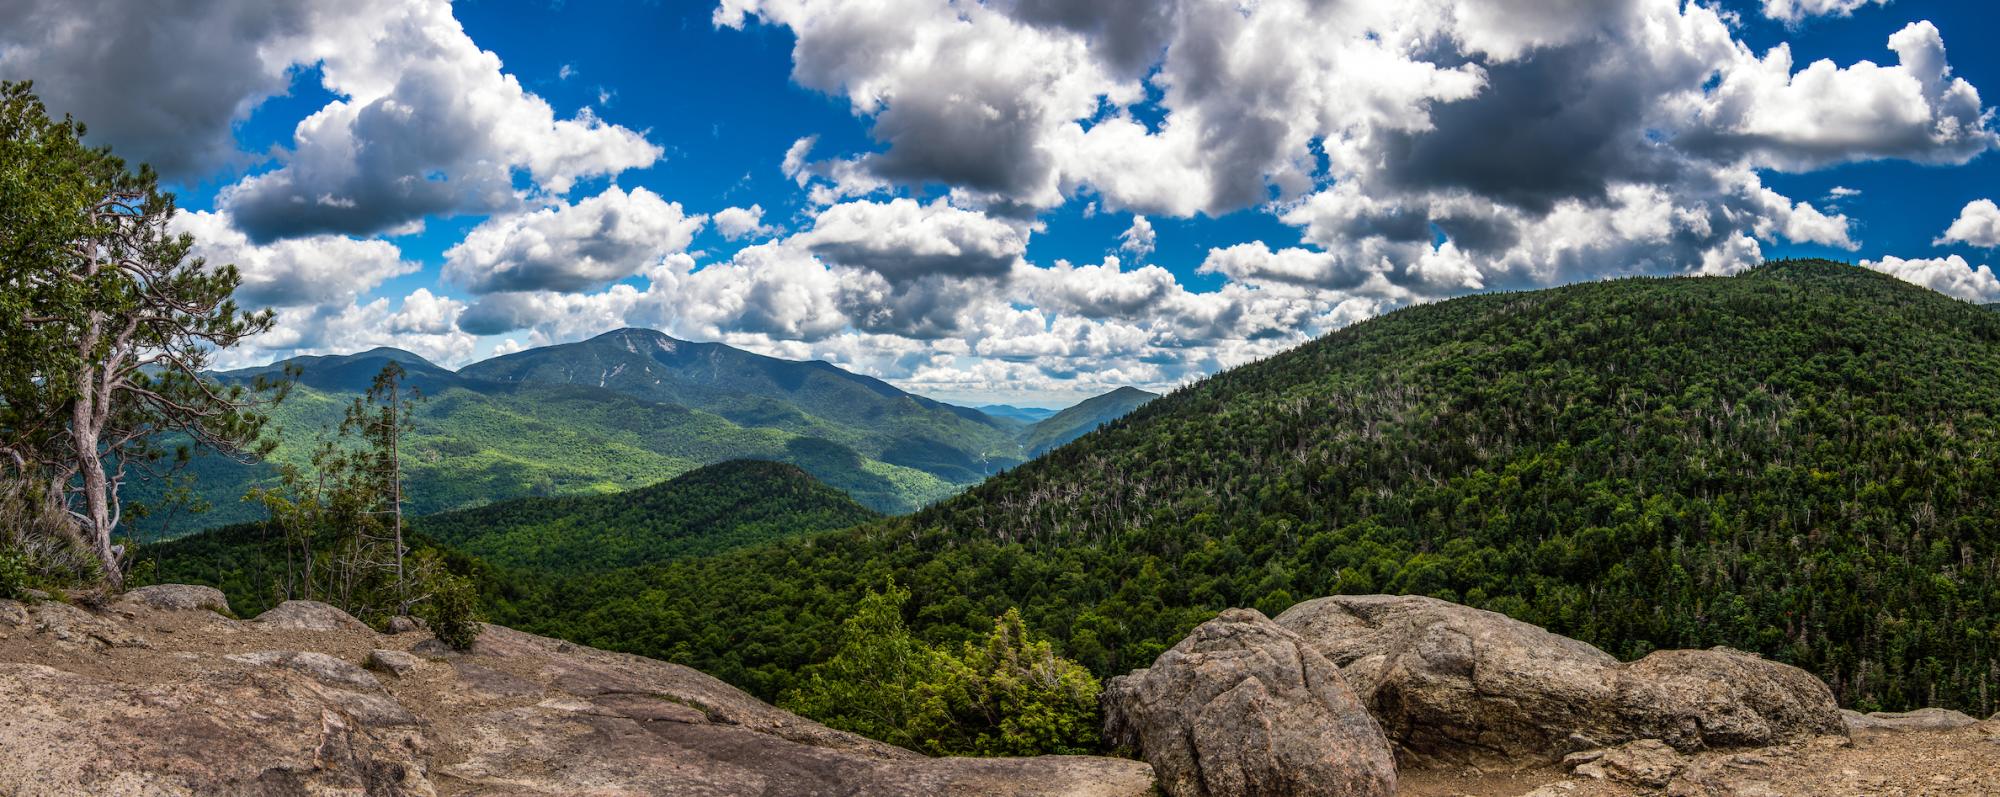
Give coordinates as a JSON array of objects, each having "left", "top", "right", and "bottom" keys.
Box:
[{"left": 0, "top": 0, "right": 662, "bottom": 242}]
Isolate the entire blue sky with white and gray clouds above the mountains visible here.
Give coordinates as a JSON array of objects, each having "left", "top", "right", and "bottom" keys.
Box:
[{"left": 0, "top": 0, "right": 2000, "bottom": 407}]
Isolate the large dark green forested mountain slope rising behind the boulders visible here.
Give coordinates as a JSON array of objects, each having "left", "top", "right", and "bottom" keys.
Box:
[{"left": 524, "top": 262, "right": 2000, "bottom": 715}]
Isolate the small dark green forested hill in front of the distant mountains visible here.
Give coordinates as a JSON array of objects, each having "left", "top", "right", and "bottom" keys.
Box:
[{"left": 412, "top": 461, "right": 882, "bottom": 573}]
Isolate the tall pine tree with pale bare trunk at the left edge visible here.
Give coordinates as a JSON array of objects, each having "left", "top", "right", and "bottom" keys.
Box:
[{"left": 0, "top": 82, "right": 272, "bottom": 589}]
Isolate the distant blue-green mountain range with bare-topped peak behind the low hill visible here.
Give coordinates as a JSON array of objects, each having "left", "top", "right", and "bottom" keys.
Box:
[{"left": 130, "top": 328, "right": 1152, "bottom": 537}]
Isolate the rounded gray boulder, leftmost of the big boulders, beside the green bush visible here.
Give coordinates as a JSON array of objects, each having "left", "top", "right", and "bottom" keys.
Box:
[{"left": 1104, "top": 609, "right": 1396, "bottom": 797}]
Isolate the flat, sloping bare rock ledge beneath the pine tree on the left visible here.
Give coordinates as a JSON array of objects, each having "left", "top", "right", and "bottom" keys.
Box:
[{"left": 0, "top": 587, "right": 1152, "bottom": 797}]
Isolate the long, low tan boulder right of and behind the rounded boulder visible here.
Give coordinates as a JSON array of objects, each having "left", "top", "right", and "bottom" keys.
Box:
[{"left": 1278, "top": 595, "right": 1846, "bottom": 765}]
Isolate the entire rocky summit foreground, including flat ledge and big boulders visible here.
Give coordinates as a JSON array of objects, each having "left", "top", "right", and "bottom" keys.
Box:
[{"left": 0, "top": 587, "right": 2000, "bottom": 797}]
